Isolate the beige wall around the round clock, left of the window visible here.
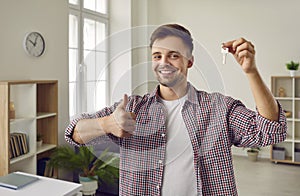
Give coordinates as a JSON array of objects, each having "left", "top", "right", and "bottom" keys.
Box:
[{"left": 0, "top": 0, "right": 69, "bottom": 143}]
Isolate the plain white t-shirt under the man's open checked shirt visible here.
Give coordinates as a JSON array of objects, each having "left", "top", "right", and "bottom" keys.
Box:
[{"left": 162, "top": 95, "right": 197, "bottom": 196}]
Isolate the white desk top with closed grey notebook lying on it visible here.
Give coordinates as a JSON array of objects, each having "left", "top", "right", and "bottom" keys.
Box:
[{"left": 0, "top": 172, "right": 82, "bottom": 196}]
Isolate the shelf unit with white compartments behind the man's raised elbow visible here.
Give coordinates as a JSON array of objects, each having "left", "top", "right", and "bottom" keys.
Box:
[{"left": 271, "top": 76, "right": 300, "bottom": 164}]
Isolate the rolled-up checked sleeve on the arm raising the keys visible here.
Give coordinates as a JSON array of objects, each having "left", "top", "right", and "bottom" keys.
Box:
[{"left": 229, "top": 101, "right": 287, "bottom": 147}]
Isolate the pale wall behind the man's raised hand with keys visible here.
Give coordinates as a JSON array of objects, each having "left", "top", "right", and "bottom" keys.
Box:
[{"left": 144, "top": 0, "right": 300, "bottom": 157}]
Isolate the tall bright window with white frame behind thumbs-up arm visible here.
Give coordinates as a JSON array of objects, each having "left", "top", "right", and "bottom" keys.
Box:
[{"left": 69, "top": 0, "right": 108, "bottom": 117}]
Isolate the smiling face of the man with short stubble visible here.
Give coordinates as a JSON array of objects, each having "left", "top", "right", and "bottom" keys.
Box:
[{"left": 152, "top": 36, "right": 193, "bottom": 87}]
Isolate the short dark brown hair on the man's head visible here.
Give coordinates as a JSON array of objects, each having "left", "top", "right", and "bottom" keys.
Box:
[{"left": 150, "top": 24, "right": 194, "bottom": 54}]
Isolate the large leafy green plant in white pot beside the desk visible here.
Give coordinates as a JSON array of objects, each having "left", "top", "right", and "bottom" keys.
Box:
[{"left": 49, "top": 145, "right": 119, "bottom": 195}]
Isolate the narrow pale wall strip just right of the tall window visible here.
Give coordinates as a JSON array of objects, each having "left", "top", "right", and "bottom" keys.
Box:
[{"left": 108, "top": 0, "right": 132, "bottom": 103}]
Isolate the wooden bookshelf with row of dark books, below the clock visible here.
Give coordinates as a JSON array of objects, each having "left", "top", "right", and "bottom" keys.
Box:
[{"left": 0, "top": 80, "right": 58, "bottom": 176}]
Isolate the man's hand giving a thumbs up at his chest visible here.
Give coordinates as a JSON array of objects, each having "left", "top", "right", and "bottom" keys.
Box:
[{"left": 111, "top": 94, "right": 136, "bottom": 137}]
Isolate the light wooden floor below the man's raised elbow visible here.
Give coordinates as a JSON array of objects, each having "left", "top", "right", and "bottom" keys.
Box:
[{"left": 97, "top": 156, "right": 300, "bottom": 196}]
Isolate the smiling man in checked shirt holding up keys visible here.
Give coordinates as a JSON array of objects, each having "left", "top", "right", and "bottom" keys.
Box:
[{"left": 66, "top": 24, "right": 286, "bottom": 196}]
